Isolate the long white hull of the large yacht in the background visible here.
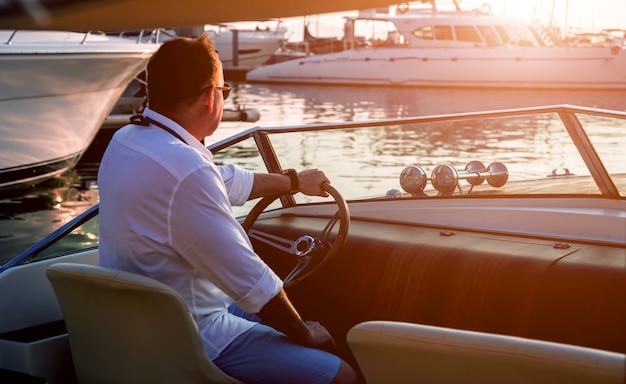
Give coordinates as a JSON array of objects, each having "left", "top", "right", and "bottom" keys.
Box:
[{"left": 247, "top": 46, "right": 626, "bottom": 89}]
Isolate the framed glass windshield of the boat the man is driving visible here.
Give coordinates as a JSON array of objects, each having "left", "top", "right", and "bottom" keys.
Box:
[{"left": 215, "top": 106, "right": 626, "bottom": 218}]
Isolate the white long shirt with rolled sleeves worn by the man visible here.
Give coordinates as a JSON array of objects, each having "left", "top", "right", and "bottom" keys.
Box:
[{"left": 98, "top": 109, "right": 282, "bottom": 359}]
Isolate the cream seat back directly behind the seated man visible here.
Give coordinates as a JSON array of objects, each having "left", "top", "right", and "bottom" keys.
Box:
[{"left": 46, "top": 263, "right": 240, "bottom": 384}]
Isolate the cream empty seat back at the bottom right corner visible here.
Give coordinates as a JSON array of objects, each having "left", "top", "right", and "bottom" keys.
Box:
[{"left": 348, "top": 321, "right": 626, "bottom": 384}]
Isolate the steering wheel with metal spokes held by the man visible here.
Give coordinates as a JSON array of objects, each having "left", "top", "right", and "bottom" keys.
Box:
[{"left": 242, "top": 183, "right": 350, "bottom": 287}]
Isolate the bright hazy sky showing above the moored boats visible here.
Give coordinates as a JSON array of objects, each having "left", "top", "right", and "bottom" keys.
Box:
[{"left": 274, "top": 0, "right": 626, "bottom": 41}]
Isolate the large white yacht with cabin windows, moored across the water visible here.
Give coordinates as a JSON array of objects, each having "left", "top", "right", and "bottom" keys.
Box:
[{"left": 247, "top": 2, "right": 626, "bottom": 89}]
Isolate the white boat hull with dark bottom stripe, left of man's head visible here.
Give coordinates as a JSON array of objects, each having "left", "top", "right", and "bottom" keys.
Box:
[{"left": 0, "top": 34, "right": 156, "bottom": 189}]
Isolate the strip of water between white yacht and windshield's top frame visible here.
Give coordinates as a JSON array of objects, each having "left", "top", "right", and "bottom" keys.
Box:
[{"left": 226, "top": 83, "right": 626, "bottom": 127}]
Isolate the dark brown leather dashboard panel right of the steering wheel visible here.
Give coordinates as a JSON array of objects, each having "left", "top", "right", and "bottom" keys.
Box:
[{"left": 292, "top": 219, "right": 626, "bottom": 353}]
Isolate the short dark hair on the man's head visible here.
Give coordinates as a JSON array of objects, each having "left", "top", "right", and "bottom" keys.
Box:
[{"left": 147, "top": 34, "right": 218, "bottom": 112}]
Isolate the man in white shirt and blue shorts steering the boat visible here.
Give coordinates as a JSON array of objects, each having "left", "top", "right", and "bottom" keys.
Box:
[{"left": 98, "top": 35, "right": 356, "bottom": 383}]
